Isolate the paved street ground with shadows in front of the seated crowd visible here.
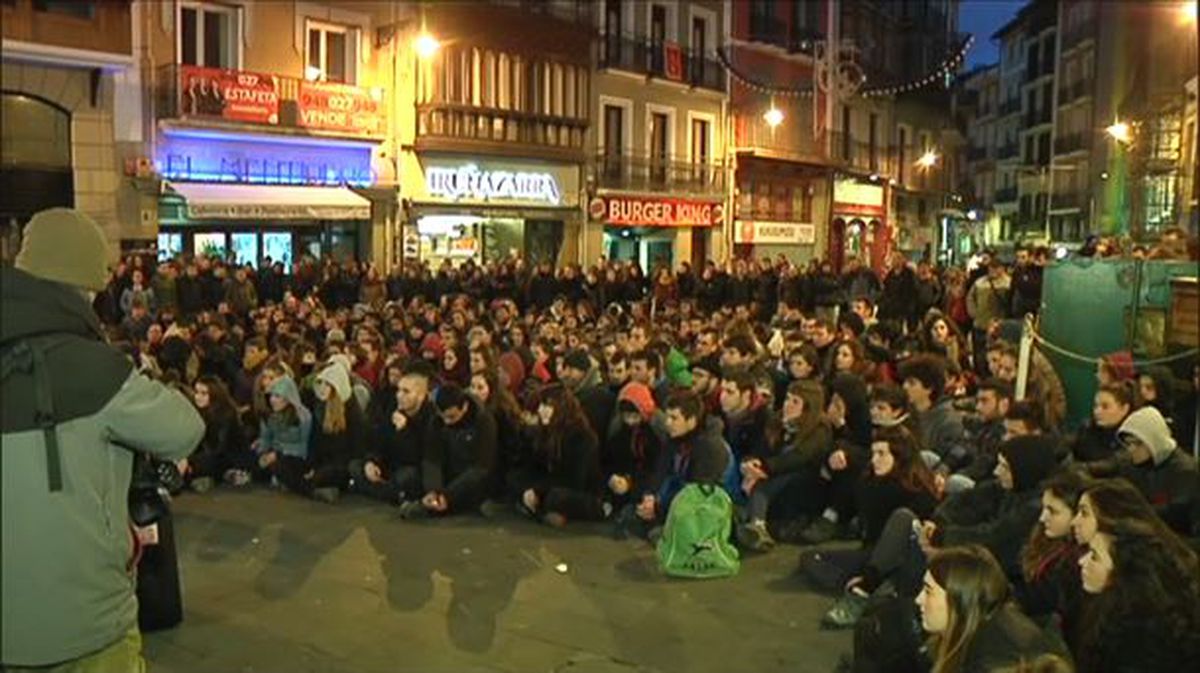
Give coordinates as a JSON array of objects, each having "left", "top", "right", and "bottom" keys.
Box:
[{"left": 146, "top": 489, "right": 850, "bottom": 673}]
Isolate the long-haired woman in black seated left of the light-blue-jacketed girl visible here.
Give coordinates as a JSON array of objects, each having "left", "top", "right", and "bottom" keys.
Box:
[{"left": 184, "top": 375, "right": 254, "bottom": 493}]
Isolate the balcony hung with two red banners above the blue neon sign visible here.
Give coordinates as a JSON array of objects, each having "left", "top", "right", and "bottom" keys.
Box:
[{"left": 155, "top": 64, "right": 386, "bottom": 139}]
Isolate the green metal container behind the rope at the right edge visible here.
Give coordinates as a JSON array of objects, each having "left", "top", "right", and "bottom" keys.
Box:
[{"left": 1040, "top": 258, "right": 1196, "bottom": 427}]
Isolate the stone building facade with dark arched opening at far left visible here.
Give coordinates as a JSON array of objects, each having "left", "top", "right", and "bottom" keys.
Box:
[{"left": 0, "top": 0, "right": 136, "bottom": 260}]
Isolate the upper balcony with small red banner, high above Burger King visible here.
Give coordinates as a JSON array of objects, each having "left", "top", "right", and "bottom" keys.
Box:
[{"left": 600, "top": 34, "right": 725, "bottom": 92}]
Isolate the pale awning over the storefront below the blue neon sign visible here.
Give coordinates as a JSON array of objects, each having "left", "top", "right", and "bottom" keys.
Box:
[{"left": 170, "top": 182, "right": 371, "bottom": 220}]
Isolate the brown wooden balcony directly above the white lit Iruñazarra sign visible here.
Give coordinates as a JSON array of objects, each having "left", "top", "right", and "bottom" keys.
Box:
[{"left": 414, "top": 103, "right": 588, "bottom": 161}]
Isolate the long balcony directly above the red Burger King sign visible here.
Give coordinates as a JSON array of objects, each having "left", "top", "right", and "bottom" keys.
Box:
[{"left": 592, "top": 154, "right": 725, "bottom": 196}]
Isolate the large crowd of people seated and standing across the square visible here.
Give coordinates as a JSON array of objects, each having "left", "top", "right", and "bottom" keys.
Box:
[{"left": 94, "top": 238, "right": 1200, "bottom": 673}]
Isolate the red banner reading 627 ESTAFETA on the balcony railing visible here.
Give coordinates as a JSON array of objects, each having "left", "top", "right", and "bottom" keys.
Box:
[{"left": 179, "top": 66, "right": 280, "bottom": 124}]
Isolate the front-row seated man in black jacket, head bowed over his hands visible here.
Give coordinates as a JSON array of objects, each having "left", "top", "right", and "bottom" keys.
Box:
[{"left": 400, "top": 384, "right": 499, "bottom": 518}]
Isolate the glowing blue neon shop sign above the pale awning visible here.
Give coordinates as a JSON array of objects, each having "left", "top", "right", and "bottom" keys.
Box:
[{"left": 155, "top": 130, "right": 374, "bottom": 187}]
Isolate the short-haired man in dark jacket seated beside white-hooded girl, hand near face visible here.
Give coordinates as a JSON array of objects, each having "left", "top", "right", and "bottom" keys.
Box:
[{"left": 350, "top": 366, "right": 437, "bottom": 504}]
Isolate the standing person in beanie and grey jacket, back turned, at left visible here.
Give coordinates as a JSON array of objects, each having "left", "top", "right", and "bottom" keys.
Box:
[{"left": 0, "top": 209, "right": 204, "bottom": 671}]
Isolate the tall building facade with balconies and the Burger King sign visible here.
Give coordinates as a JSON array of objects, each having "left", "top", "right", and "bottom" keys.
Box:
[{"left": 581, "top": 0, "right": 728, "bottom": 270}]
